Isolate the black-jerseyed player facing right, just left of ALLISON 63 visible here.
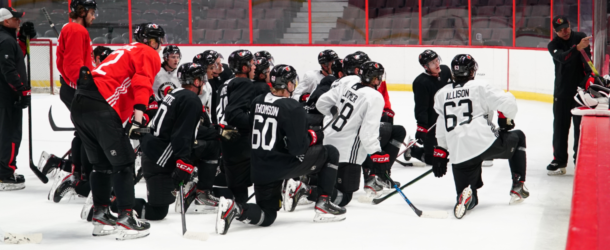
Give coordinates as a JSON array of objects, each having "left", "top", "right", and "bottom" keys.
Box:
[{"left": 405, "top": 49, "right": 453, "bottom": 164}]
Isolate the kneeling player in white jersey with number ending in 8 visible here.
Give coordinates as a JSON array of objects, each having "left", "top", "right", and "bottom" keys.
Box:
[{"left": 316, "top": 59, "right": 391, "bottom": 206}]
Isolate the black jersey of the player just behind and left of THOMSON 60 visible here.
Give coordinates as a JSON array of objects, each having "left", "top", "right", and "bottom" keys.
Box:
[{"left": 216, "top": 77, "right": 255, "bottom": 135}]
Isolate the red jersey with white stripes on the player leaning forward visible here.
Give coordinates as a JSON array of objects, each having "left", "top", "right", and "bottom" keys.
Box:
[{"left": 91, "top": 42, "right": 161, "bottom": 122}]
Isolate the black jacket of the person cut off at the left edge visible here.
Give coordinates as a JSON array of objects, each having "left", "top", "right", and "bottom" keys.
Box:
[{"left": 0, "top": 25, "right": 28, "bottom": 108}]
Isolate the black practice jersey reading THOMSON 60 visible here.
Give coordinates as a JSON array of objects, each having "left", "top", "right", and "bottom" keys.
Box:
[{"left": 250, "top": 93, "right": 311, "bottom": 183}]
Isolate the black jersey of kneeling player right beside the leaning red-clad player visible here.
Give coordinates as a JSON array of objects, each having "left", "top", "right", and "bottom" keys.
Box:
[{"left": 141, "top": 88, "right": 203, "bottom": 166}]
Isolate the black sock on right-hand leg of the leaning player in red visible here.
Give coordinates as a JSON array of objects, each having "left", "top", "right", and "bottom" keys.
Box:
[{"left": 112, "top": 165, "right": 135, "bottom": 211}]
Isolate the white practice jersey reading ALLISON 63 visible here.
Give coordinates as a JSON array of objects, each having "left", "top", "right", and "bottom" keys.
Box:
[{"left": 434, "top": 81, "right": 517, "bottom": 164}]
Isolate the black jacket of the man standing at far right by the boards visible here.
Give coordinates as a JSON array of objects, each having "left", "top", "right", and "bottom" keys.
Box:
[{"left": 547, "top": 31, "right": 591, "bottom": 98}]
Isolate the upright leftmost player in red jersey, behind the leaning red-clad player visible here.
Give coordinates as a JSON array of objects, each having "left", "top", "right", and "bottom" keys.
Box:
[{"left": 48, "top": 0, "right": 97, "bottom": 202}]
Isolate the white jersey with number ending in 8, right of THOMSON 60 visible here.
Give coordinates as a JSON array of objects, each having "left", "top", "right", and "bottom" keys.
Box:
[{"left": 316, "top": 81, "right": 384, "bottom": 165}]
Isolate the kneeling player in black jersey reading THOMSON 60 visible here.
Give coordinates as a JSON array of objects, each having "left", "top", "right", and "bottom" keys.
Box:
[{"left": 216, "top": 64, "right": 345, "bottom": 234}]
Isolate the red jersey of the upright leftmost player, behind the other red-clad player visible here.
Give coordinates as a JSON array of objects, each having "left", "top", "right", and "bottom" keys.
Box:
[{"left": 55, "top": 22, "right": 93, "bottom": 88}]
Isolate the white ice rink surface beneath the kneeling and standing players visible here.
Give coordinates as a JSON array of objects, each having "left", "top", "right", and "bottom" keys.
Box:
[{"left": 0, "top": 92, "right": 574, "bottom": 250}]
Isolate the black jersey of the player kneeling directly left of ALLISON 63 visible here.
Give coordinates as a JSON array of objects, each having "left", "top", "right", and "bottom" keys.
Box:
[{"left": 413, "top": 65, "right": 453, "bottom": 129}]
